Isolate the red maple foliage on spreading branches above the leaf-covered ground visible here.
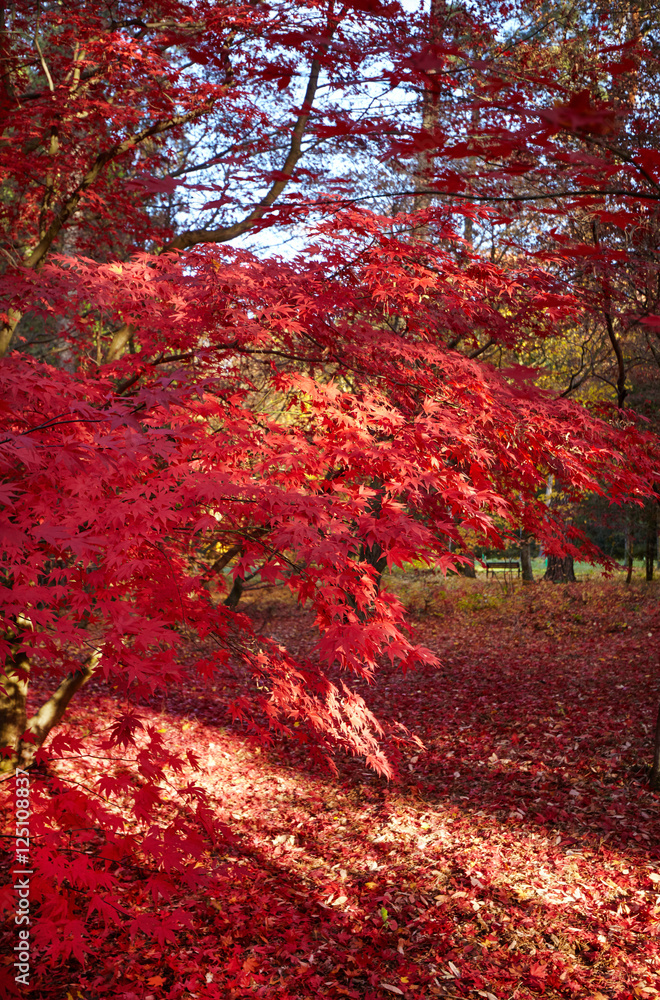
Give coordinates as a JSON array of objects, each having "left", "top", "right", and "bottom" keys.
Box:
[{"left": 0, "top": 0, "right": 659, "bottom": 997}]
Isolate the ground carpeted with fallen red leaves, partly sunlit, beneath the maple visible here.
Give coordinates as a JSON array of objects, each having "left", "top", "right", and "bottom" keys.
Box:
[{"left": 3, "top": 573, "right": 660, "bottom": 1000}]
